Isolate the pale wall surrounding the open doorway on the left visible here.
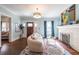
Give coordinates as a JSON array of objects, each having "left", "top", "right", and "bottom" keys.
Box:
[{"left": 0, "top": 6, "right": 20, "bottom": 41}]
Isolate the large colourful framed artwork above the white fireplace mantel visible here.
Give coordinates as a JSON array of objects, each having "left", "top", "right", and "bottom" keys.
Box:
[{"left": 61, "top": 4, "right": 76, "bottom": 25}]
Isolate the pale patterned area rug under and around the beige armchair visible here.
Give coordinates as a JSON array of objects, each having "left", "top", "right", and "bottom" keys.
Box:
[{"left": 20, "top": 44, "right": 70, "bottom": 55}]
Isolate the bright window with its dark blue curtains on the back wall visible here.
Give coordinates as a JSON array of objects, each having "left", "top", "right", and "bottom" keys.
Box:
[{"left": 44, "top": 21, "right": 54, "bottom": 38}]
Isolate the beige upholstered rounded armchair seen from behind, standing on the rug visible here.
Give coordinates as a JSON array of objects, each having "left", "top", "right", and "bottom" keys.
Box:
[{"left": 27, "top": 33, "right": 43, "bottom": 52}]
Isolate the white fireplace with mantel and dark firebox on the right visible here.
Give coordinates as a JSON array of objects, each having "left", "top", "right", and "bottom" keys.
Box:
[{"left": 57, "top": 24, "right": 79, "bottom": 51}]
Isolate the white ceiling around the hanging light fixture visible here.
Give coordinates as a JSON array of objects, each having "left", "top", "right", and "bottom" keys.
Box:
[{"left": 2, "top": 4, "right": 71, "bottom": 17}]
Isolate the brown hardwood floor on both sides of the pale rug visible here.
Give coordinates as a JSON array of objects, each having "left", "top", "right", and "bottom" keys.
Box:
[{"left": 0, "top": 39, "right": 79, "bottom": 55}]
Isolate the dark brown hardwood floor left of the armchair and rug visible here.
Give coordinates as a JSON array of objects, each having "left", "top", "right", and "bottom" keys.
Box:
[{"left": 0, "top": 39, "right": 26, "bottom": 55}]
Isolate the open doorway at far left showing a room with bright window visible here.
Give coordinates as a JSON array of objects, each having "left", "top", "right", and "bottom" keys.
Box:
[{"left": 1, "top": 15, "right": 11, "bottom": 45}]
